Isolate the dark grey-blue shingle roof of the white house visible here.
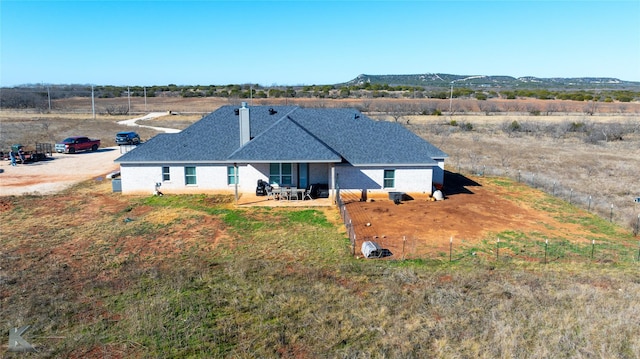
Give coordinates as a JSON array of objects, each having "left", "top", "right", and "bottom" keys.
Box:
[{"left": 116, "top": 106, "right": 447, "bottom": 166}]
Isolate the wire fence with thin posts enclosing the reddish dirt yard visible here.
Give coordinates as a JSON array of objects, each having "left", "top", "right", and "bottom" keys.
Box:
[{"left": 336, "top": 170, "right": 640, "bottom": 264}]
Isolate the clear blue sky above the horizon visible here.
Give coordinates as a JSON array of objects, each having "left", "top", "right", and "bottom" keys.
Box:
[{"left": 0, "top": 0, "right": 640, "bottom": 86}]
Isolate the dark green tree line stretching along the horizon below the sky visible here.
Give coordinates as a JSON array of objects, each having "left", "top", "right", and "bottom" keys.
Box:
[{"left": 0, "top": 83, "right": 640, "bottom": 109}]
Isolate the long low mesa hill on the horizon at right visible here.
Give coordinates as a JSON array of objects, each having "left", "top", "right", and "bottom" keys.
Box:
[{"left": 340, "top": 73, "right": 640, "bottom": 91}]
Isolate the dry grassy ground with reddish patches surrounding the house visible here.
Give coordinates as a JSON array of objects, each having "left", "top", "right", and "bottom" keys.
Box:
[{"left": 0, "top": 99, "right": 640, "bottom": 358}]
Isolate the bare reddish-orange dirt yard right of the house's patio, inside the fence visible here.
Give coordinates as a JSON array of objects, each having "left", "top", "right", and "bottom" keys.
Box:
[{"left": 346, "top": 172, "right": 604, "bottom": 259}]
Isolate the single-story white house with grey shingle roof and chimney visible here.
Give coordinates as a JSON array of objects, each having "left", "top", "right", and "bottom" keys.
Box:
[{"left": 115, "top": 103, "right": 447, "bottom": 196}]
